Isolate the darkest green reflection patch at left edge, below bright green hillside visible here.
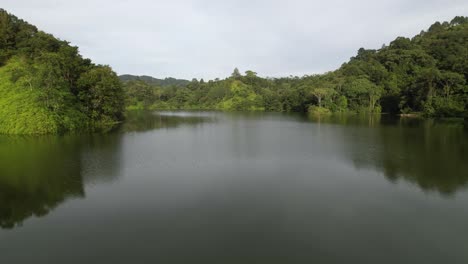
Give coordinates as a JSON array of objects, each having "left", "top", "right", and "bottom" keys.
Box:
[{"left": 0, "top": 137, "right": 85, "bottom": 228}]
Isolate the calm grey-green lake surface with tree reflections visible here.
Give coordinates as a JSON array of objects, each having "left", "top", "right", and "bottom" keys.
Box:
[{"left": 0, "top": 112, "right": 468, "bottom": 264}]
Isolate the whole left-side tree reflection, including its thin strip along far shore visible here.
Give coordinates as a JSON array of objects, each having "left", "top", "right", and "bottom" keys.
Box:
[{"left": 0, "top": 112, "right": 213, "bottom": 229}]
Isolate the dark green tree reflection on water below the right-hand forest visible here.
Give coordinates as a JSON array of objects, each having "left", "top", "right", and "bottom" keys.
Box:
[{"left": 373, "top": 119, "right": 468, "bottom": 195}]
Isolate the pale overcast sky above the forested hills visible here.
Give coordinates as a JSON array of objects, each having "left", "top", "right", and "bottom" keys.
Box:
[{"left": 0, "top": 0, "right": 468, "bottom": 80}]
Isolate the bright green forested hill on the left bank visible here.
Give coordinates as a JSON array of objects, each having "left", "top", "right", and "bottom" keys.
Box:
[{"left": 0, "top": 9, "right": 124, "bottom": 134}]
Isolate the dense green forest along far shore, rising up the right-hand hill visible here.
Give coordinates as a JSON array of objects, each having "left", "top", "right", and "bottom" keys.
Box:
[{"left": 124, "top": 17, "right": 468, "bottom": 117}]
